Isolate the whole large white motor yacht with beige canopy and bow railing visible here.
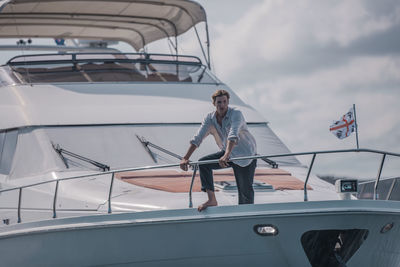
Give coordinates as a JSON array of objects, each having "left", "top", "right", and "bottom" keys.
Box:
[{"left": 0, "top": 0, "right": 400, "bottom": 266}]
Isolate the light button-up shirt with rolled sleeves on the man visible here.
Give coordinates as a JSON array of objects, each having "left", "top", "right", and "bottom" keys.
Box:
[{"left": 190, "top": 107, "right": 257, "bottom": 167}]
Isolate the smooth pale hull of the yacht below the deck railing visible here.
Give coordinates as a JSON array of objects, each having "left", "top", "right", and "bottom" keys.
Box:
[{"left": 0, "top": 200, "right": 400, "bottom": 267}]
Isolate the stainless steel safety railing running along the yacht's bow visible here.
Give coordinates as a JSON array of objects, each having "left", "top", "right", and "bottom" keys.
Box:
[{"left": 0, "top": 148, "right": 400, "bottom": 223}]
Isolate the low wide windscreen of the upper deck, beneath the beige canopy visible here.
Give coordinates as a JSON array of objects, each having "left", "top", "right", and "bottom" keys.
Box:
[{"left": 7, "top": 53, "right": 219, "bottom": 83}]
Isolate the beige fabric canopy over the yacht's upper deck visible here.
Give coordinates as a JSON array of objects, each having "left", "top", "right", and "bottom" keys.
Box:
[{"left": 0, "top": 0, "right": 206, "bottom": 51}]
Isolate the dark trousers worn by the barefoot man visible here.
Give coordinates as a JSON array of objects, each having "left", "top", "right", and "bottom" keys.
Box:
[{"left": 199, "top": 151, "right": 257, "bottom": 204}]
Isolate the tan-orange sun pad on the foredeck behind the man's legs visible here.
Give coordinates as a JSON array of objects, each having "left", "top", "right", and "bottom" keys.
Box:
[{"left": 117, "top": 169, "right": 312, "bottom": 193}]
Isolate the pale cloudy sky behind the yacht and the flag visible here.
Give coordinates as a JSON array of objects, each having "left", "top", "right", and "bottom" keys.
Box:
[{"left": 0, "top": 0, "right": 400, "bottom": 180}]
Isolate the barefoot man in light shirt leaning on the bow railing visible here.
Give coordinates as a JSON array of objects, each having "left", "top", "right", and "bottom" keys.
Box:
[{"left": 180, "top": 90, "right": 257, "bottom": 211}]
